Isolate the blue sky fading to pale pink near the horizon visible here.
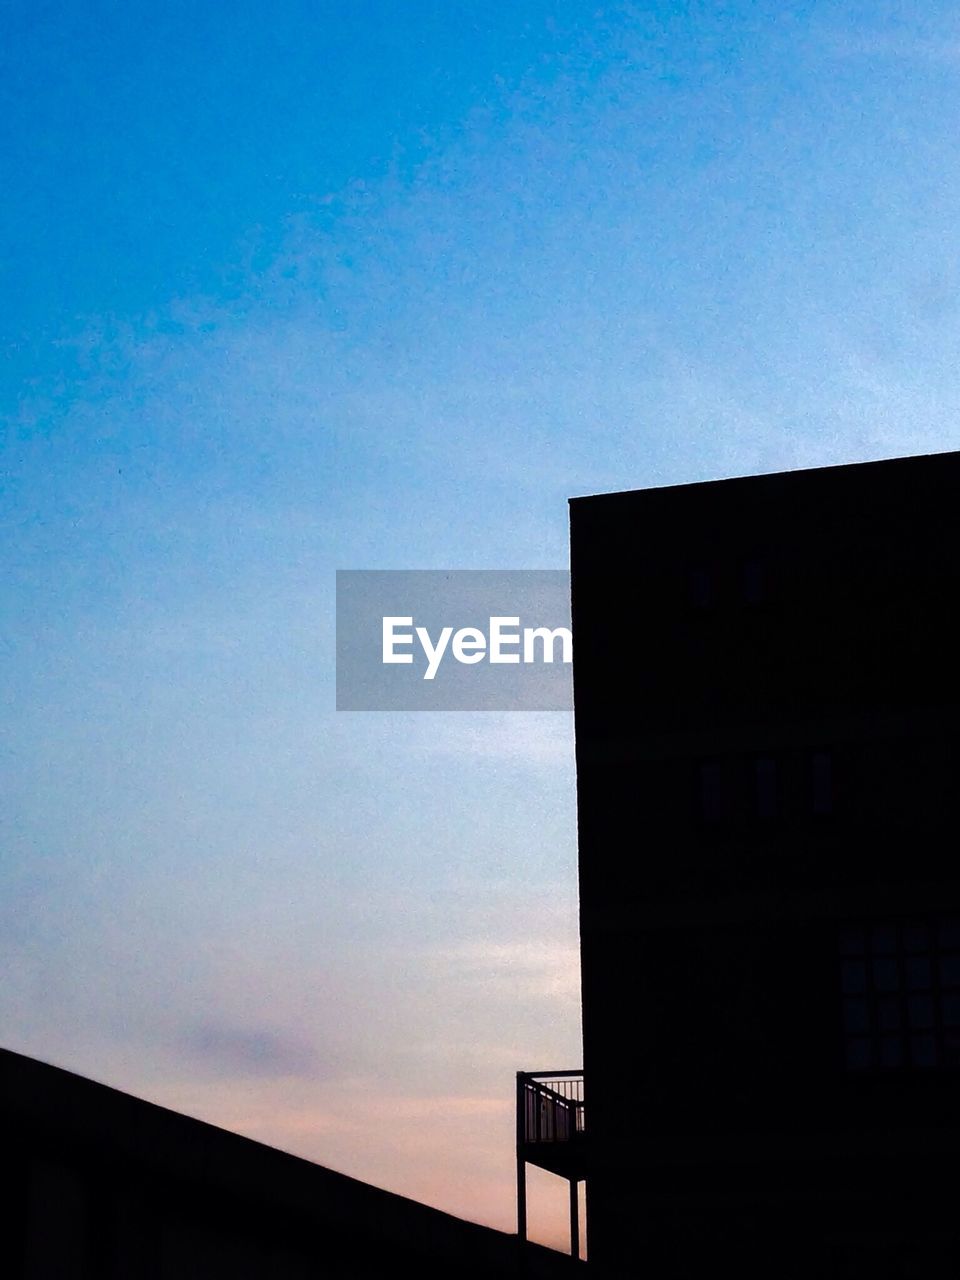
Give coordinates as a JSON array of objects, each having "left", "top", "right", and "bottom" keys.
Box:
[{"left": 0, "top": 0, "right": 960, "bottom": 1247}]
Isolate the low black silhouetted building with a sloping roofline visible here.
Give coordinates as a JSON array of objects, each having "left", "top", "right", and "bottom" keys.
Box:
[{"left": 0, "top": 1050, "right": 586, "bottom": 1280}]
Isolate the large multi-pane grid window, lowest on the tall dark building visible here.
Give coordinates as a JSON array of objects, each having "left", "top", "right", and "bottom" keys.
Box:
[{"left": 840, "top": 919, "right": 960, "bottom": 1071}]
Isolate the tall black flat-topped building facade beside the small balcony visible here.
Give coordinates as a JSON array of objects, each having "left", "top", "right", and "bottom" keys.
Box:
[{"left": 571, "top": 453, "right": 960, "bottom": 1280}]
